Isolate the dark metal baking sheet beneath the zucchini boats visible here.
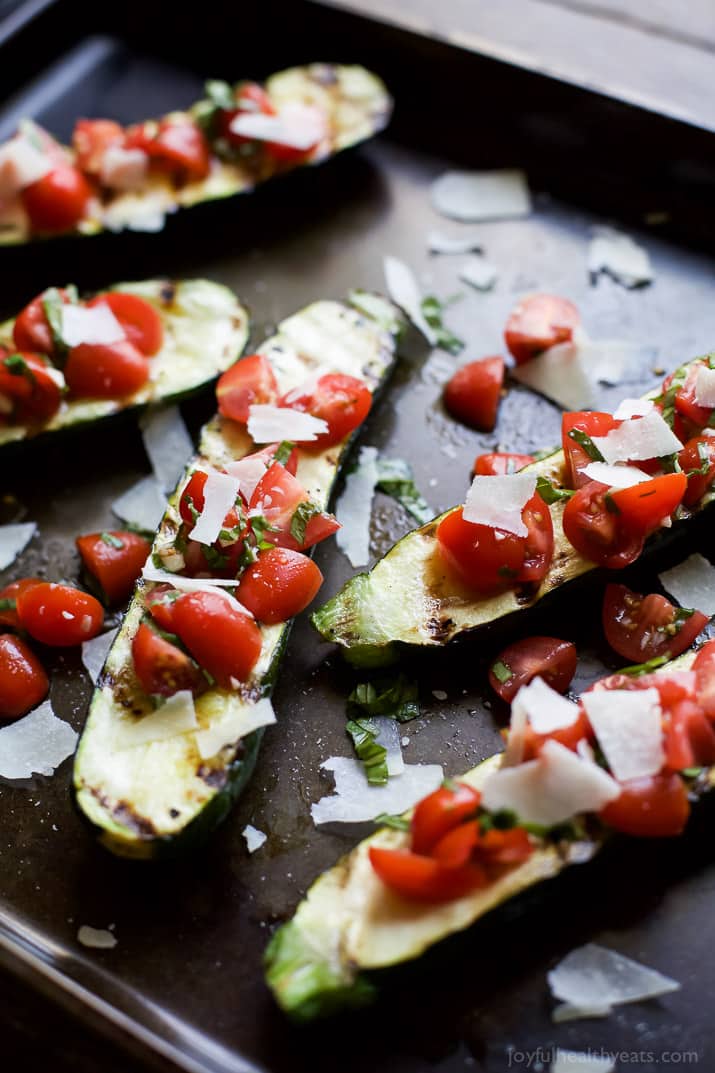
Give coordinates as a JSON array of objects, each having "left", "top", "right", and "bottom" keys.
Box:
[{"left": 0, "top": 3, "right": 715, "bottom": 1073}]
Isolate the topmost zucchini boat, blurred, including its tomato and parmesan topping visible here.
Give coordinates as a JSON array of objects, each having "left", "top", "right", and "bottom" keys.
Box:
[{"left": 0, "top": 63, "right": 392, "bottom": 246}]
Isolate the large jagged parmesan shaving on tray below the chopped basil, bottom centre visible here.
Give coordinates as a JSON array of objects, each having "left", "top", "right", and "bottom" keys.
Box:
[{"left": 310, "top": 756, "right": 443, "bottom": 824}]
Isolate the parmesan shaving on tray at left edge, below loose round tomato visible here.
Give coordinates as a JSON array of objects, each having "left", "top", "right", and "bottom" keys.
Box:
[{"left": 0, "top": 701, "right": 77, "bottom": 779}]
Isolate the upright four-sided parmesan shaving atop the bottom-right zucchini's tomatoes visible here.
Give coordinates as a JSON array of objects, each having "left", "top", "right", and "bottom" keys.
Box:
[{"left": 582, "top": 689, "right": 666, "bottom": 782}]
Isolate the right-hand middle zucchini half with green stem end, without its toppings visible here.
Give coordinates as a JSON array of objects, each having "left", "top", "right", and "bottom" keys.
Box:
[{"left": 311, "top": 358, "right": 715, "bottom": 665}]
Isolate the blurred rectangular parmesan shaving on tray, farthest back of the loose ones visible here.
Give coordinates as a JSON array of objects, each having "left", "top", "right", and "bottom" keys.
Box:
[{"left": 432, "top": 168, "right": 531, "bottom": 220}]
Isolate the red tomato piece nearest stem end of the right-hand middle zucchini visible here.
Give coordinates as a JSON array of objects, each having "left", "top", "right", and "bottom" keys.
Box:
[{"left": 437, "top": 493, "right": 554, "bottom": 594}]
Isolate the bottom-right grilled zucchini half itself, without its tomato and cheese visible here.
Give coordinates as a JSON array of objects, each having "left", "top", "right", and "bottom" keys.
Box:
[{"left": 264, "top": 642, "right": 715, "bottom": 1021}]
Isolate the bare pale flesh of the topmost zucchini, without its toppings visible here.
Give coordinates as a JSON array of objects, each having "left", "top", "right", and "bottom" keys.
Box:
[{"left": 0, "top": 63, "right": 392, "bottom": 246}]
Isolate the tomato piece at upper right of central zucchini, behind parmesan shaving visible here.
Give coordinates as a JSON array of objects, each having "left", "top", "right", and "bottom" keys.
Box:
[{"left": 278, "top": 372, "right": 373, "bottom": 451}]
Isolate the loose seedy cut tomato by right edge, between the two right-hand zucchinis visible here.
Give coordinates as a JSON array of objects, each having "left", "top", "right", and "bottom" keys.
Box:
[{"left": 601, "top": 584, "right": 707, "bottom": 663}]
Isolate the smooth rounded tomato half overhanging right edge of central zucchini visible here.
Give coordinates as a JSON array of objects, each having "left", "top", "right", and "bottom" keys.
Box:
[{"left": 236, "top": 547, "right": 323, "bottom": 626}]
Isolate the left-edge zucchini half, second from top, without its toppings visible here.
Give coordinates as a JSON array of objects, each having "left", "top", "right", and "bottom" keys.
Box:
[{"left": 0, "top": 279, "right": 249, "bottom": 447}]
